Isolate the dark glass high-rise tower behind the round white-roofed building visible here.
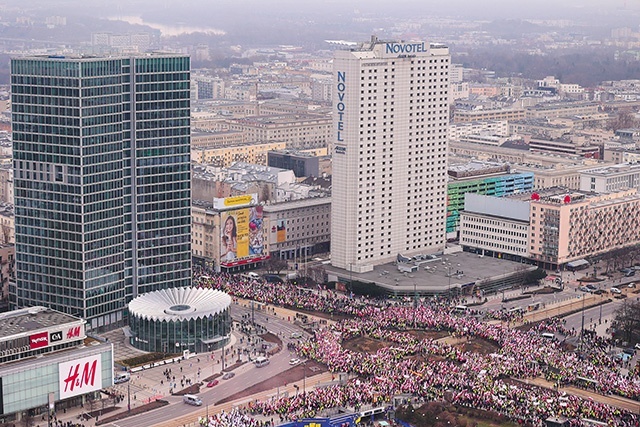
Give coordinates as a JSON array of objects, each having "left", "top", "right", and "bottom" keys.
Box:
[{"left": 10, "top": 54, "right": 191, "bottom": 328}]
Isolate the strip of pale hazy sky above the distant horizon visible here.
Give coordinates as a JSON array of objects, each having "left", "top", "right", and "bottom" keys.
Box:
[{"left": 16, "top": 0, "right": 640, "bottom": 21}]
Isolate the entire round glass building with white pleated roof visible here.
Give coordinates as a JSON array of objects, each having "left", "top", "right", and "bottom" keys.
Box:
[{"left": 129, "top": 288, "right": 231, "bottom": 353}]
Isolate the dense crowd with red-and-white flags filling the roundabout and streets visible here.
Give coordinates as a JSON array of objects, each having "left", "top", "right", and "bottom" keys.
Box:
[{"left": 195, "top": 274, "right": 640, "bottom": 426}]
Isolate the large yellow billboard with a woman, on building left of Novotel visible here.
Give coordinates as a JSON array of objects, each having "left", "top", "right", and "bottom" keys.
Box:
[{"left": 220, "top": 206, "right": 269, "bottom": 267}]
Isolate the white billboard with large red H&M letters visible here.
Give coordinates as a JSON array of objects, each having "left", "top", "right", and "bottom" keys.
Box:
[{"left": 58, "top": 354, "right": 102, "bottom": 400}]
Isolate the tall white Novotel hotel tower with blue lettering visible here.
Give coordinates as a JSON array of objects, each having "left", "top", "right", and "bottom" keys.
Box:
[{"left": 331, "top": 37, "right": 450, "bottom": 272}]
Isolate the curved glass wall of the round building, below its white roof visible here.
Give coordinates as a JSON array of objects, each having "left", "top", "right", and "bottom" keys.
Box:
[{"left": 129, "top": 307, "right": 231, "bottom": 353}]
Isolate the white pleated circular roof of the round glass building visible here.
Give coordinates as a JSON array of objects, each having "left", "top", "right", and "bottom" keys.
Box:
[{"left": 129, "top": 288, "right": 231, "bottom": 322}]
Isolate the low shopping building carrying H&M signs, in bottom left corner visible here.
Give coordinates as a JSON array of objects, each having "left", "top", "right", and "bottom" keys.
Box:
[{"left": 0, "top": 307, "right": 115, "bottom": 425}]
